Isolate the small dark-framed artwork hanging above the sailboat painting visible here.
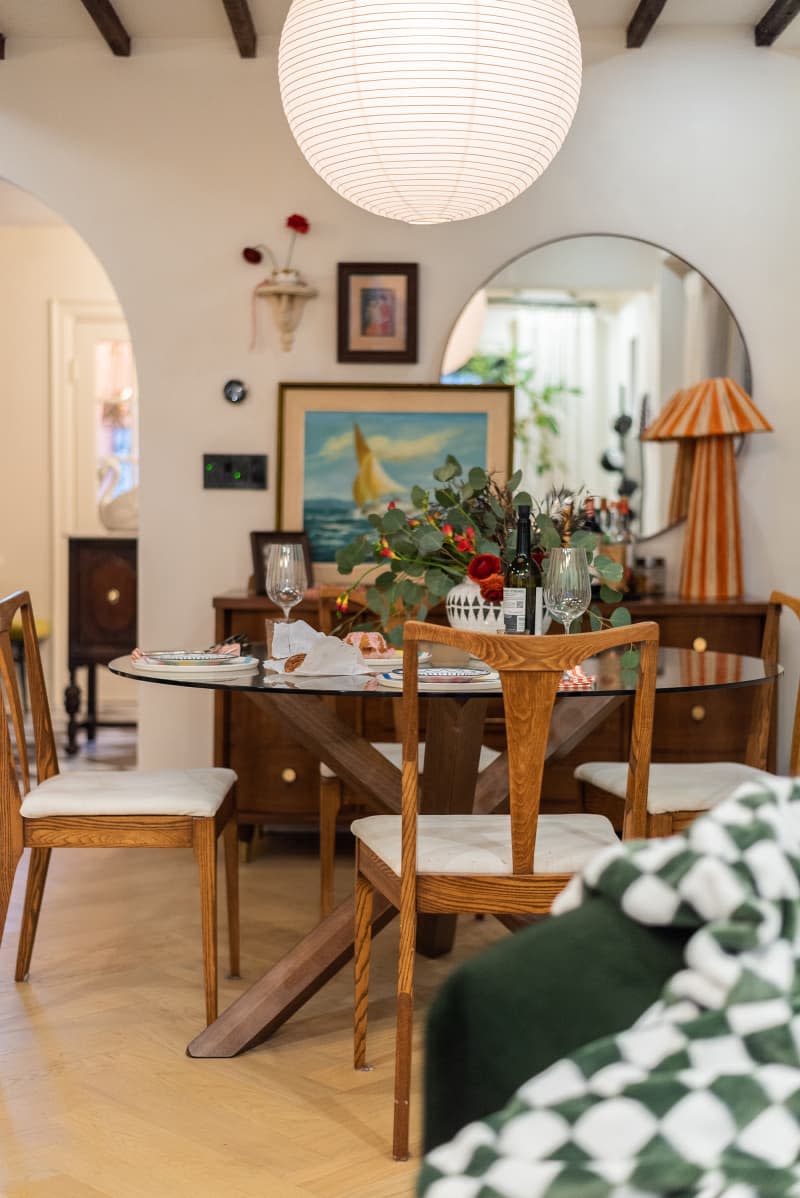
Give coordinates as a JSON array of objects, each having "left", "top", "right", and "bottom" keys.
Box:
[{"left": 337, "top": 262, "right": 418, "bottom": 362}]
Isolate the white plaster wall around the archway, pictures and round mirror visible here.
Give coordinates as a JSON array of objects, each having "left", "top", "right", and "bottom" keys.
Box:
[{"left": 0, "top": 28, "right": 800, "bottom": 764}]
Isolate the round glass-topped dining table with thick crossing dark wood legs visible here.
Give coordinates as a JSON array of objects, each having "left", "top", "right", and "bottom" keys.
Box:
[{"left": 109, "top": 645, "right": 782, "bottom": 1057}]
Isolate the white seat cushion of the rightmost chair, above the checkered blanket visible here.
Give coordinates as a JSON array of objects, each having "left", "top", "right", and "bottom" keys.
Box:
[{"left": 575, "top": 761, "right": 775, "bottom": 816}]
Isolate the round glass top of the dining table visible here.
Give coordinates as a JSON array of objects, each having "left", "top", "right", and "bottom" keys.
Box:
[{"left": 109, "top": 645, "right": 783, "bottom": 698}]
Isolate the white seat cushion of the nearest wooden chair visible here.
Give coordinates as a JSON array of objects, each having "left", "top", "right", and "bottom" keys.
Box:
[{"left": 351, "top": 815, "right": 619, "bottom": 875}]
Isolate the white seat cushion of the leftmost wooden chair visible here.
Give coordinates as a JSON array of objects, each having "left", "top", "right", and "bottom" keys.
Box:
[{"left": 22, "top": 769, "right": 236, "bottom": 819}]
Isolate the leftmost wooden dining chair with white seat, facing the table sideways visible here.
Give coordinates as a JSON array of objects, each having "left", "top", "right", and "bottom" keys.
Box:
[{"left": 0, "top": 591, "right": 238, "bottom": 1023}]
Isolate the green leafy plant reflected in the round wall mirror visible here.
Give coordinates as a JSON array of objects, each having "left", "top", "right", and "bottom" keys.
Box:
[{"left": 462, "top": 349, "right": 582, "bottom": 477}]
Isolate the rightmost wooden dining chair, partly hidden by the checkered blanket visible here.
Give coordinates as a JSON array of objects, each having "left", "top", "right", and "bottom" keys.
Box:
[{"left": 574, "top": 591, "right": 800, "bottom": 836}]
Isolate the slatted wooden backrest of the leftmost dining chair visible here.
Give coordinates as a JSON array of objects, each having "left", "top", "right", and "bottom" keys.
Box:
[{"left": 0, "top": 591, "right": 59, "bottom": 835}]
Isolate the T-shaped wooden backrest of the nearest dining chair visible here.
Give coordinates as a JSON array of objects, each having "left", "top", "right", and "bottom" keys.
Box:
[{"left": 402, "top": 621, "right": 659, "bottom": 873}]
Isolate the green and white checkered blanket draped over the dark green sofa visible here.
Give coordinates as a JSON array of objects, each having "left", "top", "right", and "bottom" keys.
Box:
[{"left": 418, "top": 778, "right": 800, "bottom": 1198}]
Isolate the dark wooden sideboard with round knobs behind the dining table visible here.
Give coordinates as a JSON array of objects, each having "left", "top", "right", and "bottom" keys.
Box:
[{"left": 213, "top": 592, "right": 776, "bottom": 830}]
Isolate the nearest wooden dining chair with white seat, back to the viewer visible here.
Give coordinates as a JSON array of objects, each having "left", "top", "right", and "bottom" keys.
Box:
[{"left": 352, "top": 622, "right": 659, "bottom": 1160}]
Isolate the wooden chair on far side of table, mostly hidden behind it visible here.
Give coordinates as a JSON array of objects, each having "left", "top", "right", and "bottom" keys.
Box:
[{"left": 319, "top": 586, "right": 499, "bottom": 920}]
